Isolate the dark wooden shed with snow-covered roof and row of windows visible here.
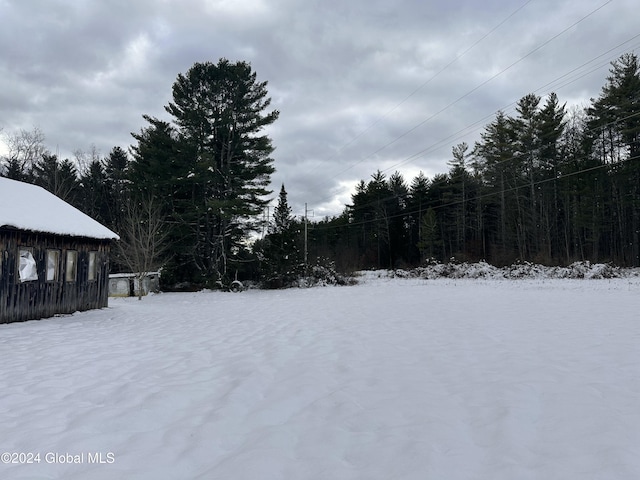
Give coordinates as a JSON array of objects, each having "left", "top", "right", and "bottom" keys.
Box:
[{"left": 0, "top": 178, "right": 118, "bottom": 323}]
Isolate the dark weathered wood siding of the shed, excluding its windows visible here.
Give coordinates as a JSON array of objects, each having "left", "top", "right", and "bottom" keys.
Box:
[{"left": 0, "top": 229, "right": 110, "bottom": 323}]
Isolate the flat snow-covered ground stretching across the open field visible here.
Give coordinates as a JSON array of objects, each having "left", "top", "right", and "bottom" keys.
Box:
[{"left": 0, "top": 273, "right": 640, "bottom": 480}]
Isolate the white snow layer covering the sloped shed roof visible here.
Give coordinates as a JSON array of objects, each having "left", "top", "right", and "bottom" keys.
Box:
[{"left": 0, "top": 177, "right": 120, "bottom": 239}]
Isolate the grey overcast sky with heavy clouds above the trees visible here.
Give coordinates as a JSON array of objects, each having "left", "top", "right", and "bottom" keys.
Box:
[{"left": 0, "top": 0, "right": 640, "bottom": 217}]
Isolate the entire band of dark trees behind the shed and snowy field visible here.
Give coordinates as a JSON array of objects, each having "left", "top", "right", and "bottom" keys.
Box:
[{"left": 0, "top": 54, "right": 640, "bottom": 286}]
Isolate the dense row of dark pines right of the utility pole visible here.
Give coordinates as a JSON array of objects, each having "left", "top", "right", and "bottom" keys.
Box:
[{"left": 304, "top": 54, "right": 640, "bottom": 269}]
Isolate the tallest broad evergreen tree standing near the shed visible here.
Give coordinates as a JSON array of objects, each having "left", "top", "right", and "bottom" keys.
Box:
[{"left": 165, "top": 59, "right": 278, "bottom": 282}]
